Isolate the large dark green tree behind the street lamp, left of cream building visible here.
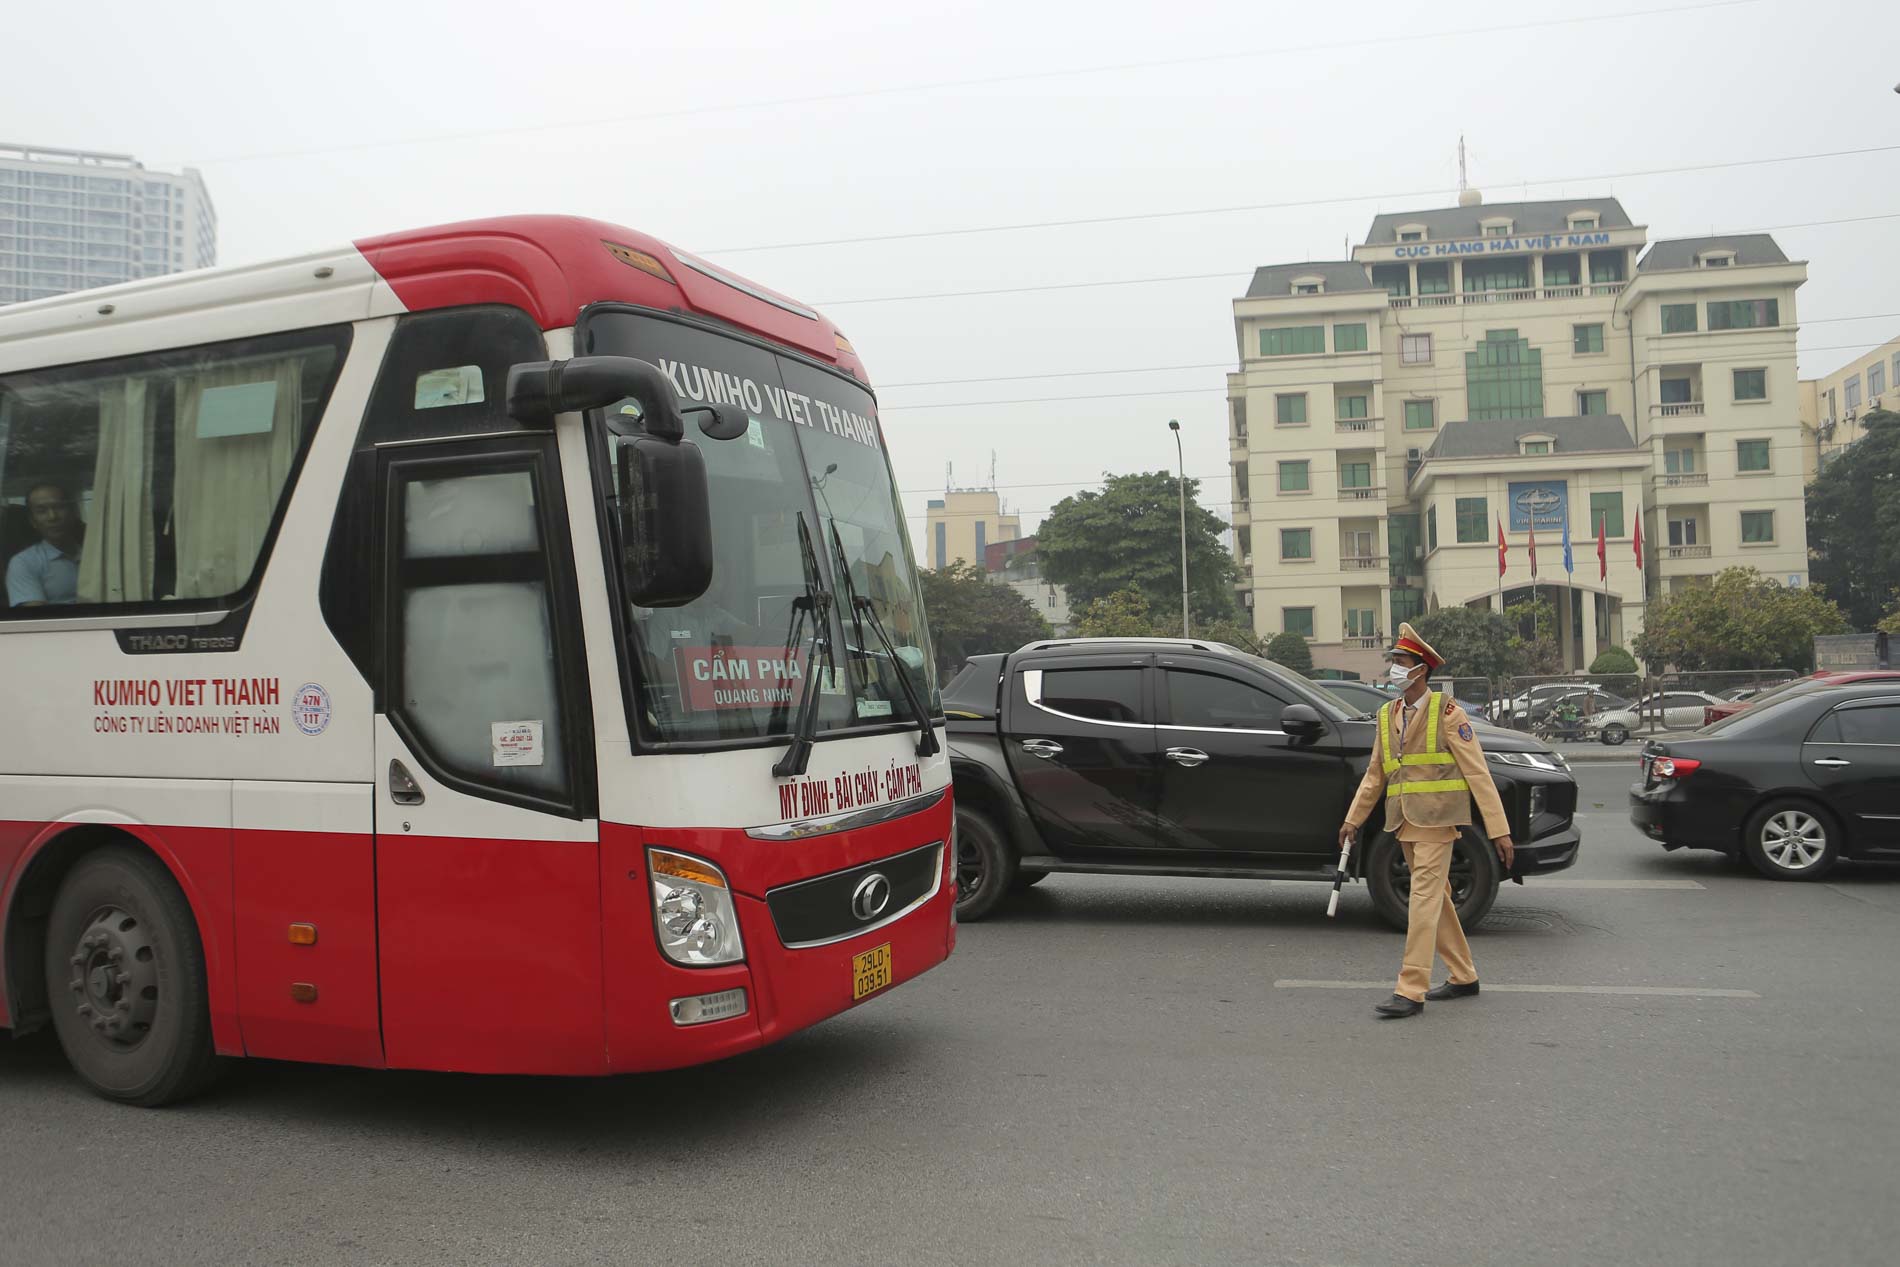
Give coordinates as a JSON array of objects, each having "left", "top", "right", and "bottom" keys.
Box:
[{"left": 1036, "top": 471, "right": 1237, "bottom": 625}]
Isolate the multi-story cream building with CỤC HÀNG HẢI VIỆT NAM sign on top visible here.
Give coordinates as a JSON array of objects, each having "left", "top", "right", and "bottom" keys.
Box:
[{"left": 1227, "top": 192, "right": 1807, "bottom": 672}]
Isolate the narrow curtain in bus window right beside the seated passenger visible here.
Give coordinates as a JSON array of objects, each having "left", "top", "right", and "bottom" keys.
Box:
[{"left": 74, "top": 378, "right": 160, "bottom": 602}]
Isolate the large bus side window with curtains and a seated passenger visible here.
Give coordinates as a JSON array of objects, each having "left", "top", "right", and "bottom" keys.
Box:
[{"left": 0, "top": 329, "right": 348, "bottom": 615}]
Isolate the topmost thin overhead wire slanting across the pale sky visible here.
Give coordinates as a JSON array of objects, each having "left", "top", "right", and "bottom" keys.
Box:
[{"left": 174, "top": 0, "right": 1761, "bottom": 167}]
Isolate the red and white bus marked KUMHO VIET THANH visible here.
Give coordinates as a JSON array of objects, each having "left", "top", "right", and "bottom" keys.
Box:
[{"left": 0, "top": 217, "right": 956, "bottom": 1104}]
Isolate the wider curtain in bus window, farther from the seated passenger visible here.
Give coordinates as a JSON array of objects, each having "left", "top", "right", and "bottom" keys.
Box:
[{"left": 171, "top": 357, "right": 304, "bottom": 598}]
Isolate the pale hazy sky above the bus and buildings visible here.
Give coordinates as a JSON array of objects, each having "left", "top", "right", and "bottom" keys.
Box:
[{"left": 0, "top": 0, "right": 1900, "bottom": 550}]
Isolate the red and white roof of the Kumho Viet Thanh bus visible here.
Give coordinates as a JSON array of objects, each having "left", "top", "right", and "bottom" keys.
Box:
[{"left": 0, "top": 215, "right": 865, "bottom": 380}]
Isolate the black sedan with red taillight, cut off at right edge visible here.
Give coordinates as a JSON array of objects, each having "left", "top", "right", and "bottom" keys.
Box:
[{"left": 1630, "top": 682, "right": 1900, "bottom": 879}]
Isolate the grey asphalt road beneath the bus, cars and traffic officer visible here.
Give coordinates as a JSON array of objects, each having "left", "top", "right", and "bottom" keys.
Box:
[{"left": 0, "top": 766, "right": 1900, "bottom": 1265}]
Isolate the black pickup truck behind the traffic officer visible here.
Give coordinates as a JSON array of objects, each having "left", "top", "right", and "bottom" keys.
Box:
[{"left": 944, "top": 638, "right": 1579, "bottom": 929}]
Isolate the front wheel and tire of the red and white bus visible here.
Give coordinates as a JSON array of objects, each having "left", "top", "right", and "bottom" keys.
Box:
[{"left": 46, "top": 845, "right": 219, "bottom": 1107}]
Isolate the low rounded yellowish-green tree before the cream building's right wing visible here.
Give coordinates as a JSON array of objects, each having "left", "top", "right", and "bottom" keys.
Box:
[{"left": 1634, "top": 568, "right": 1847, "bottom": 672}]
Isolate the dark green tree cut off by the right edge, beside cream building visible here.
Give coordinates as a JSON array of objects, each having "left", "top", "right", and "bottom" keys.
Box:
[{"left": 1807, "top": 408, "right": 1900, "bottom": 629}]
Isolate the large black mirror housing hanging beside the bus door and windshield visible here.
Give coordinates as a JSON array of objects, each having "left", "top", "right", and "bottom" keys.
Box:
[{"left": 612, "top": 438, "right": 713, "bottom": 608}]
